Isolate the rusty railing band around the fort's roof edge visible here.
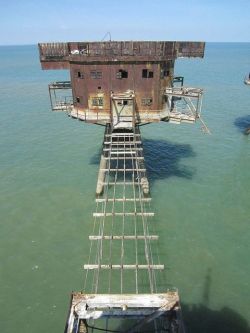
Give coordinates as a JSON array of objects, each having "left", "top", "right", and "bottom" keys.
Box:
[{"left": 39, "top": 41, "right": 205, "bottom": 61}]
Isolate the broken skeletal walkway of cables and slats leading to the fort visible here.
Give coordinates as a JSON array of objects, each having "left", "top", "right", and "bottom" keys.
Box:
[{"left": 65, "top": 125, "right": 183, "bottom": 333}]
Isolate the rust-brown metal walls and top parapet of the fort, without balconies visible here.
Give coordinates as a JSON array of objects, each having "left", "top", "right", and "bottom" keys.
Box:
[{"left": 39, "top": 41, "right": 205, "bottom": 122}]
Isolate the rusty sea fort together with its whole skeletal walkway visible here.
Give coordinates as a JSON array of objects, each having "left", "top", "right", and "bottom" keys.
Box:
[{"left": 39, "top": 41, "right": 208, "bottom": 333}]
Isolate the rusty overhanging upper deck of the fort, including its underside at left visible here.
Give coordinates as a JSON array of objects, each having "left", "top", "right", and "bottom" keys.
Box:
[{"left": 38, "top": 41, "right": 205, "bottom": 69}]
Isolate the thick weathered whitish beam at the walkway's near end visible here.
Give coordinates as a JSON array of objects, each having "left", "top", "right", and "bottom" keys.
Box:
[{"left": 67, "top": 292, "right": 179, "bottom": 322}]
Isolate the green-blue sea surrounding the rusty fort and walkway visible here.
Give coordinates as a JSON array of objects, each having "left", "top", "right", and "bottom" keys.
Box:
[{"left": 0, "top": 43, "right": 250, "bottom": 333}]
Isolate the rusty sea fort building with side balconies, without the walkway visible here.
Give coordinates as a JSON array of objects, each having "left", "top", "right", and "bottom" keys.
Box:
[{"left": 39, "top": 42, "right": 207, "bottom": 128}]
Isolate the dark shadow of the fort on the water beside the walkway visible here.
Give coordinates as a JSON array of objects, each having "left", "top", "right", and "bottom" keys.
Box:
[{"left": 90, "top": 139, "right": 195, "bottom": 184}]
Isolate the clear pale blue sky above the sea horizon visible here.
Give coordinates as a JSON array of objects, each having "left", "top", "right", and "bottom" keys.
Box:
[{"left": 0, "top": 0, "right": 250, "bottom": 45}]
